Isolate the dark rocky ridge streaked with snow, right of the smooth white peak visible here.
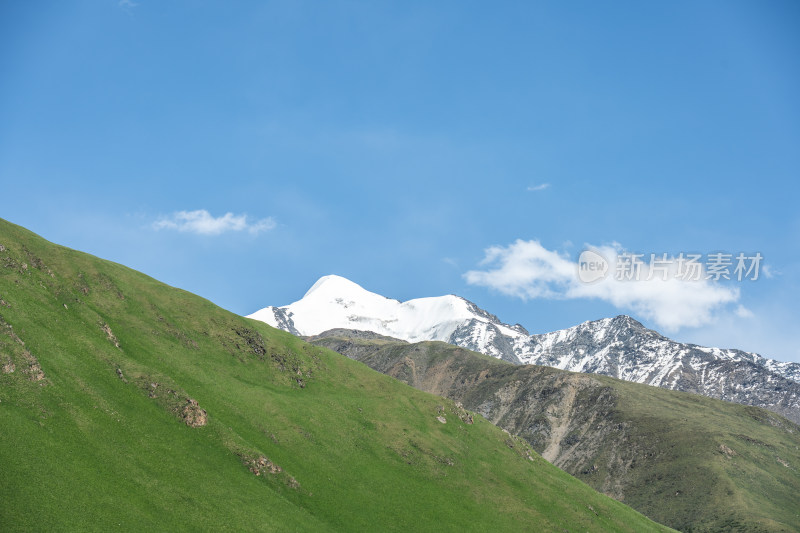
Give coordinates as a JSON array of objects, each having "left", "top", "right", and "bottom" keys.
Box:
[{"left": 516, "top": 315, "right": 800, "bottom": 422}]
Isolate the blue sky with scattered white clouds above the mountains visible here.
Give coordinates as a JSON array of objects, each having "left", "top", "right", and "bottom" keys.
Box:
[{"left": 0, "top": 0, "right": 800, "bottom": 361}]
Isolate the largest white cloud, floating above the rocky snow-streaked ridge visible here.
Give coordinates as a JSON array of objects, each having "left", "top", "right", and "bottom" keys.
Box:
[{"left": 464, "top": 240, "right": 749, "bottom": 331}]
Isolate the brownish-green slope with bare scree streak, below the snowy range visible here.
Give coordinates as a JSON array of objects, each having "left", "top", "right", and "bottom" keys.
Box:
[{"left": 313, "top": 330, "right": 800, "bottom": 531}]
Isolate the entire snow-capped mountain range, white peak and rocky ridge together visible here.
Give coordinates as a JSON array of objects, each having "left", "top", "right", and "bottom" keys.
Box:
[{"left": 249, "top": 276, "right": 800, "bottom": 423}]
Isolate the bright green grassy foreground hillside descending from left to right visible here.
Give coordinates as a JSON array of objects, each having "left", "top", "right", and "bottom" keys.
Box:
[{"left": 0, "top": 221, "right": 665, "bottom": 531}]
